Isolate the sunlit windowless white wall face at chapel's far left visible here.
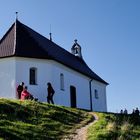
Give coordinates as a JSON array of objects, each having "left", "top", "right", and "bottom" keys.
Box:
[{"left": 0, "top": 57, "right": 16, "bottom": 98}]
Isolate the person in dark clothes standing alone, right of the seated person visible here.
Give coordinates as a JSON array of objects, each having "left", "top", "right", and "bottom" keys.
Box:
[{"left": 47, "top": 82, "right": 55, "bottom": 104}]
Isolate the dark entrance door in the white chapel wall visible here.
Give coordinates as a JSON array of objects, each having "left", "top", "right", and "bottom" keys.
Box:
[{"left": 70, "top": 86, "right": 77, "bottom": 108}]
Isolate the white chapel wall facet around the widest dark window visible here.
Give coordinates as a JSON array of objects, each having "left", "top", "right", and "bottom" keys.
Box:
[{"left": 16, "top": 57, "right": 52, "bottom": 101}]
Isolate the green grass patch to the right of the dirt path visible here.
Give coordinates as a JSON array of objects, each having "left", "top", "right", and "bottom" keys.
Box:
[{"left": 88, "top": 113, "right": 140, "bottom": 140}]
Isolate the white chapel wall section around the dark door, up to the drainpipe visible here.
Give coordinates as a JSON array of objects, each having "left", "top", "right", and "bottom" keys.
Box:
[{"left": 49, "top": 61, "right": 90, "bottom": 109}]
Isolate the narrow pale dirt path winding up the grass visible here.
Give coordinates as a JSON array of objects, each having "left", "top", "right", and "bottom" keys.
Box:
[{"left": 63, "top": 112, "right": 98, "bottom": 140}]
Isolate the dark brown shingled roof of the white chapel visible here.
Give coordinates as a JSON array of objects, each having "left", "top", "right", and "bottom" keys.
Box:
[{"left": 0, "top": 20, "right": 108, "bottom": 85}]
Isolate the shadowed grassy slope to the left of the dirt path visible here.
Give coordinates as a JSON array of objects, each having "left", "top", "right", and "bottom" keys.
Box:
[{"left": 0, "top": 99, "right": 92, "bottom": 140}]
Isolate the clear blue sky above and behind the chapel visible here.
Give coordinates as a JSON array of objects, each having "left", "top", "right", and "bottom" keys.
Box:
[{"left": 0, "top": 0, "right": 140, "bottom": 113}]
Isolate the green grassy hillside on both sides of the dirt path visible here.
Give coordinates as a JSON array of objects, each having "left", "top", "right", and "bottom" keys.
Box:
[{"left": 0, "top": 99, "right": 140, "bottom": 140}]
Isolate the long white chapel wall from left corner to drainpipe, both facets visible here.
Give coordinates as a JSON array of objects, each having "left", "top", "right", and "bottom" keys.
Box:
[{"left": 16, "top": 57, "right": 90, "bottom": 109}]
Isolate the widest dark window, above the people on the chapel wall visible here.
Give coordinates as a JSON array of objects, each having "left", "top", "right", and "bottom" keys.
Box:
[{"left": 29, "top": 67, "right": 37, "bottom": 85}]
